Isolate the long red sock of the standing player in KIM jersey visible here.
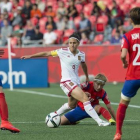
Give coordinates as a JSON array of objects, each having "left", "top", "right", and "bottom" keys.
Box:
[{"left": 116, "top": 103, "right": 127, "bottom": 135}]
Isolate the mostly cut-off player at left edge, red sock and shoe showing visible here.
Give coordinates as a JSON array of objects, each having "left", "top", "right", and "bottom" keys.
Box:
[{"left": 0, "top": 50, "right": 20, "bottom": 133}]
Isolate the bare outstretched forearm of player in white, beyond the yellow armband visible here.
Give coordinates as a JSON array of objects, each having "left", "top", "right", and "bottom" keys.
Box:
[{"left": 21, "top": 52, "right": 52, "bottom": 59}]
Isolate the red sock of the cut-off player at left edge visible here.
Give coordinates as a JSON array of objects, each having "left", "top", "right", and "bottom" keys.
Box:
[{"left": 0, "top": 93, "right": 8, "bottom": 121}]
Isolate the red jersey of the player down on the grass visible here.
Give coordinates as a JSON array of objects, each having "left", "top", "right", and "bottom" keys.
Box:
[{"left": 78, "top": 82, "right": 110, "bottom": 110}]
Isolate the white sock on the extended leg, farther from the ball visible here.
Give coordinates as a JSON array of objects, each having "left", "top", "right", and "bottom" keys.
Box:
[{"left": 83, "top": 101, "right": 102, "bottom": 124}]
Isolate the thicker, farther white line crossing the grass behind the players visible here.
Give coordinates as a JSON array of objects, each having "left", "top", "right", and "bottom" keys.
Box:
[{"left": 12, "top": 89, "right": 140, "bottom": 108}]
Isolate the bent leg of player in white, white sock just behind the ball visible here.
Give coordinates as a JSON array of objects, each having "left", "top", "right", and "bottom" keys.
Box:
[{"left": 56, "top": 96, "right": 77, "bottom": 115}]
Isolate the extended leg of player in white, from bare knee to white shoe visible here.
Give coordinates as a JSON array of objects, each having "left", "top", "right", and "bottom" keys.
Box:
[{"left": 71, "top": 87, "right": 109, "bottom": 126}]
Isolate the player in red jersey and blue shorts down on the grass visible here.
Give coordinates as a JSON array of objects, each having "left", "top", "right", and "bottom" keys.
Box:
[{"left": 61, "top": 74, "right": 116, "bottom": 125}]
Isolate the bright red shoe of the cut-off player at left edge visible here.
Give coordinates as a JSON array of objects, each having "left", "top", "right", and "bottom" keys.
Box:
[{"left": 0, "top": 121, "right": 20, "bottom": 133}]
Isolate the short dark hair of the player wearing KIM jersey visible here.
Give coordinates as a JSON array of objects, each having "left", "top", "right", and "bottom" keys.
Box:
[{"left": 130, "top": 7, "right": 140, "bottom": 25}]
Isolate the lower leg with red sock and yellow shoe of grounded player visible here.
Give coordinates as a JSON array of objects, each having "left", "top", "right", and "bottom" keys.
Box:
[{"left": 94, "top": 104, "right": 116, "bottom": 125}]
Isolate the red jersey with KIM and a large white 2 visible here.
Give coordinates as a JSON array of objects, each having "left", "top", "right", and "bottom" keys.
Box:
[{"left": 121, "top": 28, "right": 140, "bottom": 80}]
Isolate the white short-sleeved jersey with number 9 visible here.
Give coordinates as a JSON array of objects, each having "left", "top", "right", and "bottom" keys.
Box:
[{"left": 56, "top": 48, "right": 85, "bottom": 84}]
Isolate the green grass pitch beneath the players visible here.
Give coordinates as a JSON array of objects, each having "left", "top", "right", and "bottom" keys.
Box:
[{"left": 0, "top": 84, "right": 140, "bottom": 140}]
